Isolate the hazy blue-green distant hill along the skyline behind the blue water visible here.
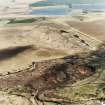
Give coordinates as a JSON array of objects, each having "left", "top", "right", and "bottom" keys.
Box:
[{"left": 30, "top": 0, "right": 105, "bottom": 7}]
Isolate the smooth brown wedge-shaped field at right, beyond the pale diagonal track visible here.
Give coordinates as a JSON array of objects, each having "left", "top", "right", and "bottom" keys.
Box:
[{"left": 67, "top": 20, "right": 105, "bottom": 41}]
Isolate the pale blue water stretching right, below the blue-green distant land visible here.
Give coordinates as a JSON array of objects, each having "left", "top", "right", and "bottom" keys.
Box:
[{"left": 29, "top": 4, "right": 105, "bottom": 15}]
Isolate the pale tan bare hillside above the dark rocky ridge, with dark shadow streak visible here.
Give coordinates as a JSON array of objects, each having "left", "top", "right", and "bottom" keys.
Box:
[{"left": 0, "top": 19, "right": 101, "bottom": 73}]
